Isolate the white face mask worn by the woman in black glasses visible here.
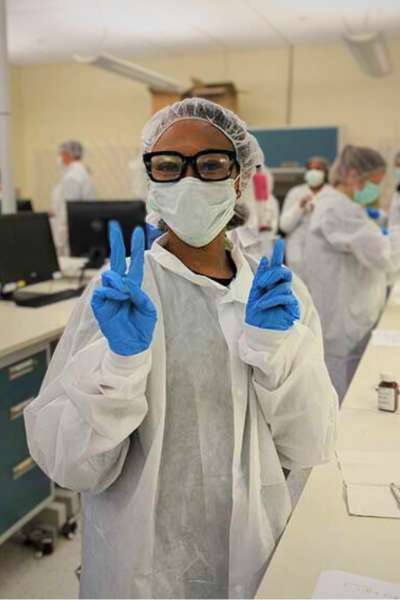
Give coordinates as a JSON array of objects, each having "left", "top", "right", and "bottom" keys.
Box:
[{"left": 148, "top": 177, "right": 236, "bottom": 248}]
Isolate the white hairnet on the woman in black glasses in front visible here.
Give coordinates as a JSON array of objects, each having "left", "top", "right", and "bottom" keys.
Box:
[{"left": 142, "top": 98, "right": 258, "bottom": 189}]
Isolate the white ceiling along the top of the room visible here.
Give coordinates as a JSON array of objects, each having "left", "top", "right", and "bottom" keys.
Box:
[{"left": 7, "top": 0, "right": 400, "bottom": 62}]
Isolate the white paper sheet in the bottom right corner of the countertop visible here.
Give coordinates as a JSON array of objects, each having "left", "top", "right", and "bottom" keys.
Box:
[{"left": 312, "top": 571, "right": 400, "bottom": 599}]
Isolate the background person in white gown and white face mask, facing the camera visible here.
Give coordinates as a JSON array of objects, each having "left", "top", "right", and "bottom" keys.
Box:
[{"left": 279, "top": 156, "right": 331, "bottom": 277}]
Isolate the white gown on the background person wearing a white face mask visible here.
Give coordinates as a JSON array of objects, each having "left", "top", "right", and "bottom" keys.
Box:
[{"left": 280, "top": 183, "right": 333, "bottom": 279}]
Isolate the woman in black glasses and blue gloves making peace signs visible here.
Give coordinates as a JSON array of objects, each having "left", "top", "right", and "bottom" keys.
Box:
[{"left": 25, "top": 98, "right": 337, "bottom": 598}]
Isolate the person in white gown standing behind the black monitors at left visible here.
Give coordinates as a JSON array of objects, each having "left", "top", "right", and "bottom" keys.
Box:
[{"left": 50, "top": 140, "right": 96, "bottom": 256}]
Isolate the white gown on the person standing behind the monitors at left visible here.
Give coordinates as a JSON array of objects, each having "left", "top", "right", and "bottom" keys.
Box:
[{"left": 51, "top": 160, "right": 96, "bottom": 256}]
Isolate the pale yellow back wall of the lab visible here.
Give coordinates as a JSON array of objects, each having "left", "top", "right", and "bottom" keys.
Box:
[{"left": 12, "top": 39, "right": 400, "bottom": 208}]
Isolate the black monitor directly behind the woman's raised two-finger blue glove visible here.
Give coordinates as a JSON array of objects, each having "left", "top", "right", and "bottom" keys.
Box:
[{"left": 67, "top": 200, "right": 147, "bottom": 268}]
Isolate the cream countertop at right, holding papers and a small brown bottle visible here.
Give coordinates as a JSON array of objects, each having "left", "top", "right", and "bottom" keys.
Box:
[{"left": 257, "top": 292, "right": 400, "bottom": 598}]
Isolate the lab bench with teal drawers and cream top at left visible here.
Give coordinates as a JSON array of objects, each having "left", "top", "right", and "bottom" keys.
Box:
[{"left": 0, "top": 286, "right": 80, "bottom": 544}]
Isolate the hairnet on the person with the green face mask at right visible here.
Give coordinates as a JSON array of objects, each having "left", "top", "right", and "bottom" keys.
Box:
[{"left": 330, "top": 145, "right": 386, "bottom": 185}]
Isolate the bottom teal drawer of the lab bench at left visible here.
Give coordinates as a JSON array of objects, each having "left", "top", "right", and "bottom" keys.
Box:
[{"left": 0, "top": 455, "right": 51, "bottom": 535}]
